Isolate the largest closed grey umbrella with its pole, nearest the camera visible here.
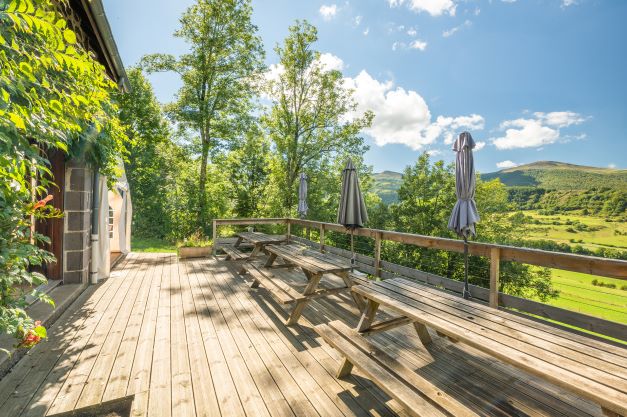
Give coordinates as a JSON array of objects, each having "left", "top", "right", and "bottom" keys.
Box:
[{"left": 448, "top": 132, "right": 480, "bottom": 299}]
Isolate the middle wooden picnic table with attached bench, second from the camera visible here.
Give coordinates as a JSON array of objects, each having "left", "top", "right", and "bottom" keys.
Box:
[{"left": 242, "top": 244, "right": 363, "bottom": 325}]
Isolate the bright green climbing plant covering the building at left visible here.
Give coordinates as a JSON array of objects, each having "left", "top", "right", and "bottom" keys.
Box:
[{"left": 0, "top": 0, "right": 126, "bottom": 347}]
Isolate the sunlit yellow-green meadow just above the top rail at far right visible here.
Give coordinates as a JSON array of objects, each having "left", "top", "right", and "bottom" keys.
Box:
[{"left": 523, "top": 210, "right": 627, "bottom": 249}]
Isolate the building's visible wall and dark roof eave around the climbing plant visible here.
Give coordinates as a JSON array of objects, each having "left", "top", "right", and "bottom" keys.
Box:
[{"left": 36, "top": 0, "right": 132, "bottom": 284}]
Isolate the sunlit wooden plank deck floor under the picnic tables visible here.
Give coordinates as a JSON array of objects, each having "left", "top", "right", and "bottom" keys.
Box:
[{"left": 0, "top": 253, "right": 612, "bottom": 417}]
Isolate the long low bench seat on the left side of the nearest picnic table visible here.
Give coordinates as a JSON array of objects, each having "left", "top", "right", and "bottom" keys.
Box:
[{"left": 314, "top": 320, "right": 477, "bottom": 416}]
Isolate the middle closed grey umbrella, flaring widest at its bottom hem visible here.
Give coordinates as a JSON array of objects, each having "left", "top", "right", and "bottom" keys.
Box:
[{"left": 337, "top": 159, "right": 368, "bottom": 265}]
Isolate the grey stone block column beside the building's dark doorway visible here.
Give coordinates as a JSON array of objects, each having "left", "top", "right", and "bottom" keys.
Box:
[{"left": 63, "top": 161, "right": 93, "bottom": 284}]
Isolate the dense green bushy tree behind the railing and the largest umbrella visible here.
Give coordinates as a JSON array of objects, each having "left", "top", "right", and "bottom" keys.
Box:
[{"left": 370, "top": 153, "right": 557, "bottom": 300}]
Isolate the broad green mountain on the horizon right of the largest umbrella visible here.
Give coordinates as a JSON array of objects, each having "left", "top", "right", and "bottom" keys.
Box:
[{"left": 481, "top": 161, "right": 627, "bottom": 190}]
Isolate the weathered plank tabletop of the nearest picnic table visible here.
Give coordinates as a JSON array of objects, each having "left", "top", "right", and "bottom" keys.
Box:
[{"left": 352, "top": 278, "right": 627, "bottom": 416}]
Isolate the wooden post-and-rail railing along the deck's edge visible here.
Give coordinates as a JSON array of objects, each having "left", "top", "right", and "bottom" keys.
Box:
[{"left": 213, "top": 218, "right": 627, "bottom": 340}]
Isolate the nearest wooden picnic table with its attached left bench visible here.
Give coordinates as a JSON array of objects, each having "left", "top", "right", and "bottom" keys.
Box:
[{"left": 315, "top": 278, "right": 627, "bottom": 416}]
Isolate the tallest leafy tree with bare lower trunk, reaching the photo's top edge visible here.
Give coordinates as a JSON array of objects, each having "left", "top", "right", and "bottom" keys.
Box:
[{"left": 142, "top": 0, "right": 264, "bottom": 232}]
